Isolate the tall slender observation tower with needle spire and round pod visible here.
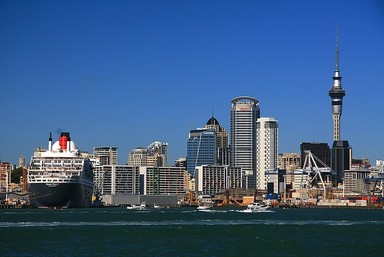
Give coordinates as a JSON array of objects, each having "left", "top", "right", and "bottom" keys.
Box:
[{"left": 329, "top": 33, "right": 345, "bottom": 141}]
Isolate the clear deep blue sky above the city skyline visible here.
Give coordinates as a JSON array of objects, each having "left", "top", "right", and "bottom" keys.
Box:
[{"left": 0, "top": 0, "right": 384, "bottom": 164}]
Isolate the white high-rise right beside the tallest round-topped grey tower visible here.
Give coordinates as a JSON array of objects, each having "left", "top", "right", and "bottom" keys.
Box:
[{"left": 256, "top": 118, "right": 278, "bottom": 190}]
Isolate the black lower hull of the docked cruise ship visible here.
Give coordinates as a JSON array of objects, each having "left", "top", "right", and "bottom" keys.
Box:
[{"left": 28, "top": 183, "right": 92, "bottom": 208}]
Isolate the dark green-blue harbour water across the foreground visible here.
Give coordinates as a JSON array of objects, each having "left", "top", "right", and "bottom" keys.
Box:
[{"left": 0, "top": 208, "right": 384, "bottom": 257}]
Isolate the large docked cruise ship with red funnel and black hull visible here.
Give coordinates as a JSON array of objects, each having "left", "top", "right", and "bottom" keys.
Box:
[{"left": 28, "top": 132, "right": 93, "bottom": 208}]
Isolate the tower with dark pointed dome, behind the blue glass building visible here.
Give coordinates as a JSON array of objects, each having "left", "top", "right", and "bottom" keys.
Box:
[{"left": 205, "top": 116, "right": 229, "bottom": 165}]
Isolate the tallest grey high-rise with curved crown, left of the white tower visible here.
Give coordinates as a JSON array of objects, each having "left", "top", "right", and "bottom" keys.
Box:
[{"left": 230, "top": 96, "right": 260, "bottom": 188}]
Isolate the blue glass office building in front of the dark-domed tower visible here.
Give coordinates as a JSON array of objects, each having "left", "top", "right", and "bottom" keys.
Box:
[{"left": 187, "top": 128, "right": 217, "bottom": 174}]
